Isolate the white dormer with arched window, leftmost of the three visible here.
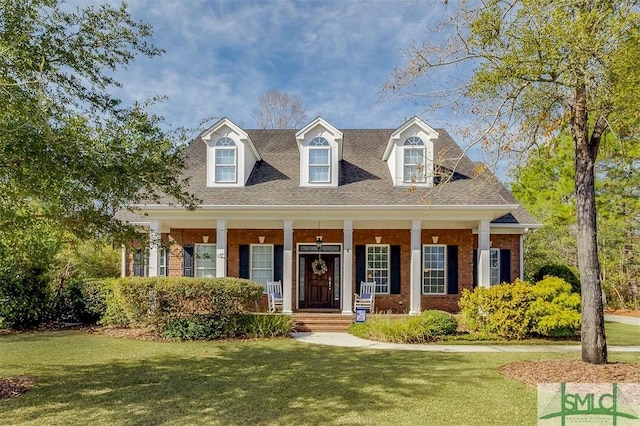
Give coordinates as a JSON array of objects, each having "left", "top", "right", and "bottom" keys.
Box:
[{"left": 202, "top": 118, "right": 260, "bottom": 187}]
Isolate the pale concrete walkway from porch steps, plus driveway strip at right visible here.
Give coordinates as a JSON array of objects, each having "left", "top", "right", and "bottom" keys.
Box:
[{"left": 292, "top": 315, "right": 640, "bottom": 352}]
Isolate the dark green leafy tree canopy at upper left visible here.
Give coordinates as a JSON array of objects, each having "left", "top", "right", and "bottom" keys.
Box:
[{"left": 0, "top": 0, "right": 194, "bottom": 240}]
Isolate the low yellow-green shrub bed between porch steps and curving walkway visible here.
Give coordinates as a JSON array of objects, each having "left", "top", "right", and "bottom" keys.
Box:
[{"left": 349, "top": 310, "right": 458, "bottom": 343}]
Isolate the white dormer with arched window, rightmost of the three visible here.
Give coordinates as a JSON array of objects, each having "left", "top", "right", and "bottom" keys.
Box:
[{"left": 383, "top": 117, "right": 438, "bottom": 187}]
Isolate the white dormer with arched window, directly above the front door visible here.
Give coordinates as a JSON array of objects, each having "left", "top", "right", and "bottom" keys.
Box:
[{"left": 296, "top": 117, "right": 343, "bottom": 188}]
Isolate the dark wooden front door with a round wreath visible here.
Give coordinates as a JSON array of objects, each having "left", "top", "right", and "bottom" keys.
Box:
[{"left": 304, "top": 253, "right": 339, "bottom": 309}]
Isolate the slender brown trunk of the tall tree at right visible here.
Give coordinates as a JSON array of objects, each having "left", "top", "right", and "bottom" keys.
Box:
[{"left": 571, "top": 90, "right": 607, "bottom": 364}]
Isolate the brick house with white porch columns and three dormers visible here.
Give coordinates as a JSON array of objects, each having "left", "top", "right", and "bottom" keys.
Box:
[{"left": 122, "top": 117, "right": 538, "bottom": 314}]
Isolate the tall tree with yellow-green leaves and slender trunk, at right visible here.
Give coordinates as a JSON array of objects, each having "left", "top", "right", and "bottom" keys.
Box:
[{"left": 386, "top": 0, "right": 640, "bottom": 364}]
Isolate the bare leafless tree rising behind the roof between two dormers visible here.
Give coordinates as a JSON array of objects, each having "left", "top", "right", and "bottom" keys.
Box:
[{"left": 256, "top": 89, "right": 307, "bottom": 129}]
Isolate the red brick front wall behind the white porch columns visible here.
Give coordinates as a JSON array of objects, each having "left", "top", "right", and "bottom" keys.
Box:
[{"left": 126, "top": 229, "right": 520, "bottom": 313}]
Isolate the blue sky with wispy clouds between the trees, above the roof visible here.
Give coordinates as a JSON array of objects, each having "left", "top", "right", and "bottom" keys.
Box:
[{"left": 106, "top": 0, "right": 455, "bottom": 133}]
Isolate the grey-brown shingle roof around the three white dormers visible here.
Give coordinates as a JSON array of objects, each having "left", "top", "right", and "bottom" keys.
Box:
[{"left": 152, "top": 129, "right": 535, "bottom": 223}]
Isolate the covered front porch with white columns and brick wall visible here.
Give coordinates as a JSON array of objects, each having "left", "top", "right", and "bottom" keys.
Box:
[{"left": 122, "top": 206, "right": 524, "bottom": 316}]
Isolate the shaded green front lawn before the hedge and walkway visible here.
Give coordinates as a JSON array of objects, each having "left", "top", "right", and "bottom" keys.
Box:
[{"left": 0, "top": 331, "right": 637, "bottom": 425}]
